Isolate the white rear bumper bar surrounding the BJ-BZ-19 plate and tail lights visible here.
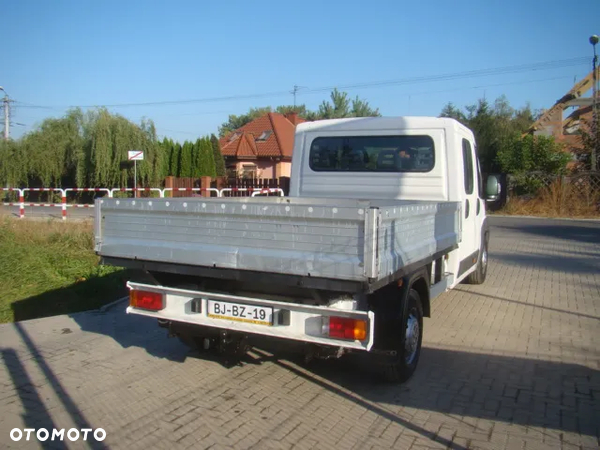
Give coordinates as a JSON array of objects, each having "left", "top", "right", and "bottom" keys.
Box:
[{"left": 127, "top": 282, "right": 375, "bottom": 351}]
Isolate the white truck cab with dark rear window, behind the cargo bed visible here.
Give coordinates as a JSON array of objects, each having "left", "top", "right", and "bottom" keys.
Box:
[{"left": 289, "top": 117, "right": 489, "bottom": 287}]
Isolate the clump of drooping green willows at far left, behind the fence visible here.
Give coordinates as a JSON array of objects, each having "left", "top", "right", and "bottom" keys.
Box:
[{"left": 0, "top": 108, "right": 166, "bottom": 187}]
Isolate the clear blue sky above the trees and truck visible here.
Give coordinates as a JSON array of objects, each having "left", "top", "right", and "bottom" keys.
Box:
[{"left": 0, "top": 0, "right": 600, "bottom": 140}]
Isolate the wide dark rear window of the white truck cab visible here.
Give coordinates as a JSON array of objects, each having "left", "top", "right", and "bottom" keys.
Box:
[{"left": 309, "top": 135, "right": 435, "bottom": 172}]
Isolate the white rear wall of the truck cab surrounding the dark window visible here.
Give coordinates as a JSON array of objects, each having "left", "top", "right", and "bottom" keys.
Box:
[{"left": 290, "top": 116, "right": 474, "bottom": 201}]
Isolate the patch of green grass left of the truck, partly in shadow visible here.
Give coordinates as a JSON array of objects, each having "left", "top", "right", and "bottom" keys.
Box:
[{"left": 0, "top": 217, "right": 129, "bottom": 323}]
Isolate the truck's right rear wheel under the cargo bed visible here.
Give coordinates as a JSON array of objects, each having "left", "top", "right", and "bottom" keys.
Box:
[{"left": 384, "top": 289, "right": 423, "bottom": 383}]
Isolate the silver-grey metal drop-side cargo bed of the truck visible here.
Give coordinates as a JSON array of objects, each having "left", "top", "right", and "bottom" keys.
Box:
[{"left": 95, "top": 197, "right": 460, "bottom": 283}]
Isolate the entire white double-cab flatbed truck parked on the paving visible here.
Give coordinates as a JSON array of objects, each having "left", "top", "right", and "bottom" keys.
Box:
[{"left": 95, "top": 117, "right": 497, "bottom": 381}]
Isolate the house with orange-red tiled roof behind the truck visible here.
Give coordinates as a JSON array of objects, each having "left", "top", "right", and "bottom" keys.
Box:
[{"left": 220, "top": 113, "right": 305, "bottom": 178}]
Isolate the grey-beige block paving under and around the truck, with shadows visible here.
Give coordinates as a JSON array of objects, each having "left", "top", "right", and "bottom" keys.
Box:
[{"left": 0, "top": 217, "right": 600, "bottom": 450}]
